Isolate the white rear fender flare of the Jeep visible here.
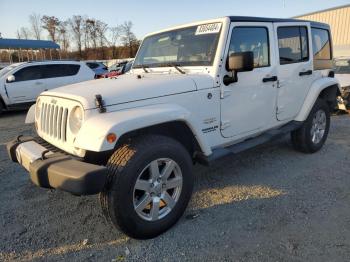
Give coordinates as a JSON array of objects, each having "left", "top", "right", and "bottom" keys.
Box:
[{"left": 295, "top": 77, "right": 339, "bottom": 121}]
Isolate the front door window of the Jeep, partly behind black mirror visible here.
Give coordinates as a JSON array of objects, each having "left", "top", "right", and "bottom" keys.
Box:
[{"left": 229, "top": 27, "right": 270, "bottom": 68}]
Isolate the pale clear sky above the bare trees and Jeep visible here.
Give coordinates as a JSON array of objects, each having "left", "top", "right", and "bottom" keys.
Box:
[{"left": 0, "top": 0, "right": 350, "bottom": 39}]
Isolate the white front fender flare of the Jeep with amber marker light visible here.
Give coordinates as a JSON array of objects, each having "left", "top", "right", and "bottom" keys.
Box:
[{"left": 74, "top": 104, "right": 211, "bottom": 155}]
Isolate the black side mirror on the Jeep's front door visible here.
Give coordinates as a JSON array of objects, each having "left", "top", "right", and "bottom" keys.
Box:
[{"left": 224, "top": 51, "right": 254, "bottom": 85}]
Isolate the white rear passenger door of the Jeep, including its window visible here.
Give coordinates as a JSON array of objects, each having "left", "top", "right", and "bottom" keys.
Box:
[{"left": 274, "top": 23, "right": 313, "bottom": 121}]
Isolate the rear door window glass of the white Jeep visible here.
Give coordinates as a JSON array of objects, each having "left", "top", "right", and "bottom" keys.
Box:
[{"left": 277, "top": 26, "right": 309, "bottom": 65}]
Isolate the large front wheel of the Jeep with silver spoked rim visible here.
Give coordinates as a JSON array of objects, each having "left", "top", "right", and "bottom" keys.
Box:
[{"left": 100, "top": 135, "right": 193, "bottom": 239}]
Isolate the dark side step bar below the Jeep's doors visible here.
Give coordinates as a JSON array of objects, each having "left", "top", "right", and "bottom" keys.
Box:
[{"left": 197, "top": 121, "right": 303, "bottom": 165}]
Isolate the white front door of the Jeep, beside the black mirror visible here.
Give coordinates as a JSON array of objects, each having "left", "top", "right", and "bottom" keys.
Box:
[{"left": 221, "top": 22, "right": 277, "bottom": 139}]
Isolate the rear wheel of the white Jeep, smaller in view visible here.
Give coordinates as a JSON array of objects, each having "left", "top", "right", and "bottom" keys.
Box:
[{"left": 291, "top": 99, "right": 330, "bottom": 153}]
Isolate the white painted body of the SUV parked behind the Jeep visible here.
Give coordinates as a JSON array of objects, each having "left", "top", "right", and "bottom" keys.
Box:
[{"left": 0, "top": 61, "right": 95, "bottom": 107}]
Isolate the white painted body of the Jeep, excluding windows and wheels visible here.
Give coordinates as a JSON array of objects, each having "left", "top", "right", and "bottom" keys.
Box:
[{"left": 28, "top": 18, "right": 337, "bottom": 159}]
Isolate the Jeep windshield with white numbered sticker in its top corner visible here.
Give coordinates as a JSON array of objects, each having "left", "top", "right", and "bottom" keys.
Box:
[{"left": 133, "top": 23, "right": 221, "bottom": 68}]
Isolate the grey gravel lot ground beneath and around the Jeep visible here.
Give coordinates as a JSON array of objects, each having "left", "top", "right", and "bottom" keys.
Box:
[{"left": 0, "top": 112, "right": 350, "bottom": 261}]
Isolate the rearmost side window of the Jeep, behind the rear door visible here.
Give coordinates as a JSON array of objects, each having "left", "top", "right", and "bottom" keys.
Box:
[{"left": 311, "top": 28, "right": 332, "bottom": 60}]
